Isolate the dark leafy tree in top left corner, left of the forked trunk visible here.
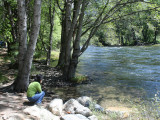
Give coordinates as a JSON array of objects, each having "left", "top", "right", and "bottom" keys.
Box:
[{"left": 0, "top": 0, "right": 18, "bottom": 57}]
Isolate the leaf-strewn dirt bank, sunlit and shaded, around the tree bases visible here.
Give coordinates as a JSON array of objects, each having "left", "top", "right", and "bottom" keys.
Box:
[{"left": 0, "top": 50, "right": 131, "bottom": 120}]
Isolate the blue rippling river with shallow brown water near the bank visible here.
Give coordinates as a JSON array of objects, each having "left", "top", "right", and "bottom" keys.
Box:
[{"left": 55, "top": 45, "right": 160, "bottom": 107}]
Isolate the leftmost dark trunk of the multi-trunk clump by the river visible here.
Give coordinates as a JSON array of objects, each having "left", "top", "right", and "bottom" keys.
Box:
[{"left": 57, "top": 0, "right": 72, "bottom": 76}]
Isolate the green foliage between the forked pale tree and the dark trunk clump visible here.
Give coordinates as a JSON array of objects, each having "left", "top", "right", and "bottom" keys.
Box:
[{"left": 35, "top": 0, "right": 61, "bottom": 59}]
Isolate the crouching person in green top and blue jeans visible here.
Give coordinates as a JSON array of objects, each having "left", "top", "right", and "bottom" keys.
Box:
[{"left": 27, "top": 75, "right": 45, "bottom": 105}]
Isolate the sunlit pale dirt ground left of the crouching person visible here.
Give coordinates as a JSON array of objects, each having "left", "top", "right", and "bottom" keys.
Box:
[{"left": 0, "top": 84, "right": 54, "bottom": 120}]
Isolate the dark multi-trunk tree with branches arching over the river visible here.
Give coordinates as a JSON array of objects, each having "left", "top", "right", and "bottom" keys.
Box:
[{"left": 57, "top": 0, "right": 158, "bottom": 80}]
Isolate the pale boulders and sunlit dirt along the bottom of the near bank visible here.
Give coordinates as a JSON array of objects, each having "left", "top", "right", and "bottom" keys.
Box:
[{"left": 0, "top": 93, "right": 132, "bottom": 120}]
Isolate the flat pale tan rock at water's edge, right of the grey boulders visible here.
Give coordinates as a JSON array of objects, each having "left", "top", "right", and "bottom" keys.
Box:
[{"left": 106, "top": 107, "right": 132, "bottom": 118}]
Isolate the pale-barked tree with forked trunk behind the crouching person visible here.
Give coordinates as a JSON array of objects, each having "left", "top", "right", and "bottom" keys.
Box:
[{"left": 13, "top": 0, "right": 41, "bottom": 92}]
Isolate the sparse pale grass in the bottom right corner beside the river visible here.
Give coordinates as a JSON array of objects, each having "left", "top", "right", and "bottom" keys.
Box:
[{"left": 90, "top": 92, "right": 160, "bottom": 120}]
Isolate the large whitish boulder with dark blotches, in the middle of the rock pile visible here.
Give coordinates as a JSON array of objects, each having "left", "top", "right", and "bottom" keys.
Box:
[{"left": 63, "top": 99, "right": 92, "bottom": 117}]
